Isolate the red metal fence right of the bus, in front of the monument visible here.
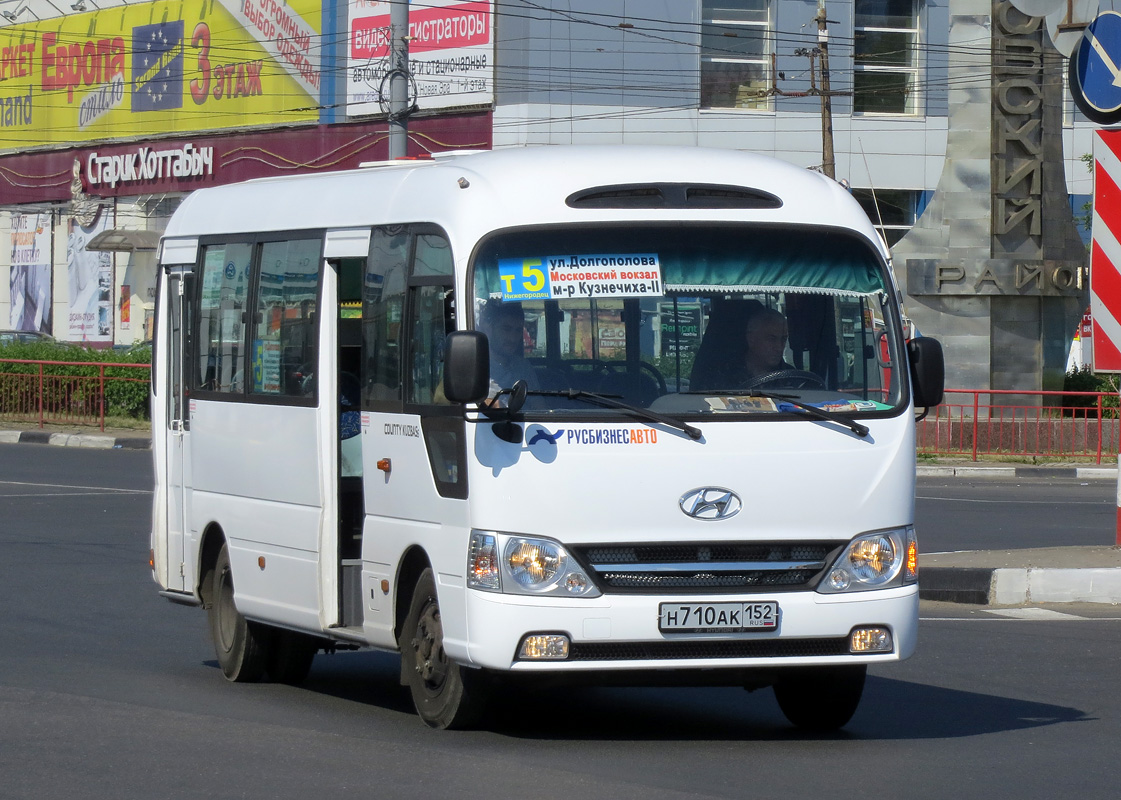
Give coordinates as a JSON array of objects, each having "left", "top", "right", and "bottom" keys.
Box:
[{"left": 917, "top": 389, "right": 1121, "bottom": 464}]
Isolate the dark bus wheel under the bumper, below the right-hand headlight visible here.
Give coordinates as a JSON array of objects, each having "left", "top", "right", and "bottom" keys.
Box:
[{"left": 775, "top": 664, "right": 868, "bottom": 732}]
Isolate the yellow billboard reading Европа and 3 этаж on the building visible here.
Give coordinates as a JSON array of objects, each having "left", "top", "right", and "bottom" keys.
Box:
[{"left": 0, "top": 0, "right": 322, "bottom": 150}]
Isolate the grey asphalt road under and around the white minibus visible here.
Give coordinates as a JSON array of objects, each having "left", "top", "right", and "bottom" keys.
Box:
[{"left": 0, "top": 445, "right": 1121, "bottom": 800}]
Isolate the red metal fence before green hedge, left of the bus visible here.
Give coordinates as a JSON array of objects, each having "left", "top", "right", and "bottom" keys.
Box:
[{"left": 0, "top": 359, "right": 151, "bottom": 430}]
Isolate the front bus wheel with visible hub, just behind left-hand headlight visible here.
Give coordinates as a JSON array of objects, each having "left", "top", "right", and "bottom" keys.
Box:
[{"left": 398, "top": 568, "right": 483, "bottom": 728}]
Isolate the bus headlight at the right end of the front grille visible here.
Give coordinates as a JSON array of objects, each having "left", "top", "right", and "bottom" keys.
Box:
[{"left": 817, "top": 527, "right": 918, "bottom": 594}]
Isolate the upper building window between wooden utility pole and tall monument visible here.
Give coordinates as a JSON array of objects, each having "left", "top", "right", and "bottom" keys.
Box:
[{"left": 852, "top": 0, "right": 919, "bottom": 114}]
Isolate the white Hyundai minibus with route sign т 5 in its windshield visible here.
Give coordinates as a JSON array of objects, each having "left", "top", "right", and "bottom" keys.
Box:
[{"left": 151, "top": 146, "right": 943, "bottom": 729}]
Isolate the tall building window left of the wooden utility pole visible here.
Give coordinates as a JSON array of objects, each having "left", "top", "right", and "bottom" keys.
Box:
[{"left": 701, "top": 0, "right": 775, "bottom": 110}]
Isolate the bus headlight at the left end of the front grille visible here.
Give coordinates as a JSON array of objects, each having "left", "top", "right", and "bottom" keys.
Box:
[{"left": 467, "top": 531, "right": 600, "bottom": 597}]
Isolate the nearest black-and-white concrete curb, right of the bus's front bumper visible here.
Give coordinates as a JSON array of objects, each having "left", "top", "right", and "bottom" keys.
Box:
[{"left": 918, "top": 567, "right": 1121, "bottom": 605}]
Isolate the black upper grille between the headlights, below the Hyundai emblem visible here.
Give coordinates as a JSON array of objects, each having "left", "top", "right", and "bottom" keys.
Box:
[{"left": 572, "top": 541, "right": 844, "bottom": 594}]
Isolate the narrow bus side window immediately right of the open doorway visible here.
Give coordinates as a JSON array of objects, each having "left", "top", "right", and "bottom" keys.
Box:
[{"left": 362, "top": 227, "right": 409, "bottom": 411}]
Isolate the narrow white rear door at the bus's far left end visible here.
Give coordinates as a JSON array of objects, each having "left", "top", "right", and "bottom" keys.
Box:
[{"left": 165, "top": 267, "right": 194, "bottom": 592}]
